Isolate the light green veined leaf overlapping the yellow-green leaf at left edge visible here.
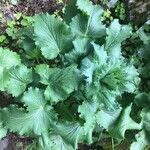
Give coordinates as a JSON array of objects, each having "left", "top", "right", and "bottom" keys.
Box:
[{"left": 6, "top": 65, "right": 33, "bottom": 97}]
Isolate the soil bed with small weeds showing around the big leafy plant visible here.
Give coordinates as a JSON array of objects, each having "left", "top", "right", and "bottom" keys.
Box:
[{"left": 0, "top": 0, "right": 150, "bottom": 150}]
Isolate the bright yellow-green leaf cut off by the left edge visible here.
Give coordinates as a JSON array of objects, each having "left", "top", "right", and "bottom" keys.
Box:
[{"left": 0, "top": 48, "right": 21, "bottom": 91}]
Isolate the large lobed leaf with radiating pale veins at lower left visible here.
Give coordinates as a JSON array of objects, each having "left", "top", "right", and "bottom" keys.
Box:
[{"left": 2, "top": 88, "right": 56, "bottom": 135}]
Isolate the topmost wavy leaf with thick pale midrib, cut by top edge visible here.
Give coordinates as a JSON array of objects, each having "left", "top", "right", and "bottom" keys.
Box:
[{"left": 70, "top": 0, "right": 105, "bottom": 38}]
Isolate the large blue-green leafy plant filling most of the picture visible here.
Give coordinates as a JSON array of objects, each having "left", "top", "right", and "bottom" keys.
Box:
[{"left": 0, "top": 0, "right": 150, "bottom": 150}]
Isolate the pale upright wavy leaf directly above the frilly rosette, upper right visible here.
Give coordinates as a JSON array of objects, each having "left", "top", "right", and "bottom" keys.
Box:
[{"left": 105, "top": 19, "right": 132, "bottom": 57}]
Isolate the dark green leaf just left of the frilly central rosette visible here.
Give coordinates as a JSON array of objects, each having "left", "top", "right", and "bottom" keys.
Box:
[{"left": 44, "top": 65, "right": 80, "bottom": 102}]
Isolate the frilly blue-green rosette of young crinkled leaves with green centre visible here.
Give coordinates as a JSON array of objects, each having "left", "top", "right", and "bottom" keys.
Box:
[{"left": 81, "top": 43, "right": 139, "bottom": 109}]
